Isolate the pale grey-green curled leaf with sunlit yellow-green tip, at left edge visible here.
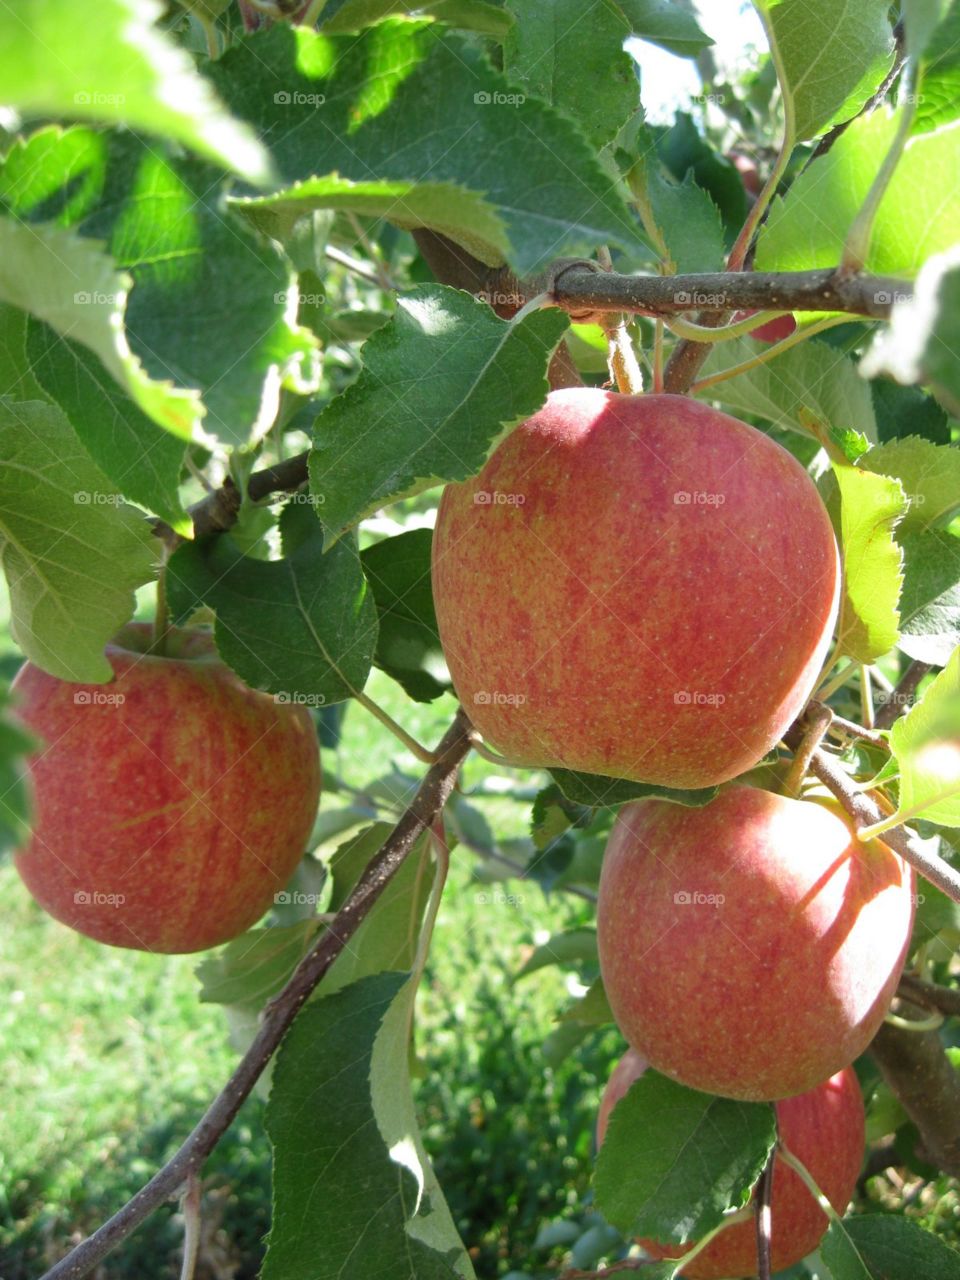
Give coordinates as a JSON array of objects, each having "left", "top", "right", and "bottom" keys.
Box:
[{"left": 0, "top": 218, "right": 202, "bottom": 440}]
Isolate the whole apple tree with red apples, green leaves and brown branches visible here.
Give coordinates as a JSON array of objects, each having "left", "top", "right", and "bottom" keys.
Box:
[{"left": 0, "top": 0, "right": 960, "bottom": 1280}]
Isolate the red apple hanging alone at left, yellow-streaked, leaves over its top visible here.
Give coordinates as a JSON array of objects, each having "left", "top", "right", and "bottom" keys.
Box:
[{"left": 13, "top": 623, "right": 320, "bottom": 952}]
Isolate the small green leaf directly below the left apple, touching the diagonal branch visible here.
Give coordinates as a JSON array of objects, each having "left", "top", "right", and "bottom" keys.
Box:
[{"left": 197, "top": 916, "right": 323, "bottom": 1009}]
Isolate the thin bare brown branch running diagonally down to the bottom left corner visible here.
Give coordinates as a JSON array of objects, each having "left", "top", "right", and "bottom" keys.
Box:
[{"left": 42, "top": 710, "right": 470, "bottom": 1280}]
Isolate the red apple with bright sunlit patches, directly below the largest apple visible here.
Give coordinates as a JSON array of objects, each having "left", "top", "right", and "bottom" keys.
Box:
[{"left": 596, "top": 786, "right": 915, "bottom": 1101}]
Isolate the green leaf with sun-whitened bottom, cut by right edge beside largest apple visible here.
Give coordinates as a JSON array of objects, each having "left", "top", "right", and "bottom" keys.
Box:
[{"left": 897, "top": 529, "right": 960, "bottom": 667}]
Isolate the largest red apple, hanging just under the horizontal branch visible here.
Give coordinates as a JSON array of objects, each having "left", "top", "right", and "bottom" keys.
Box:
[{"left": 433, "top": 388, "right": 840, "bottom": 787}]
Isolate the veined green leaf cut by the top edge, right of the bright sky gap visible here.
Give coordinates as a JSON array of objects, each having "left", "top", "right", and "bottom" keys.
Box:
[{"left": 754, "top": 0, "right": 893, "bottom": 146}]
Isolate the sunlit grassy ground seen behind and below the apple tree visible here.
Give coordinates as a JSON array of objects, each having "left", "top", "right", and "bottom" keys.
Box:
[{"left": 0, "top": 583, "right": 960, "bottom": 1280}]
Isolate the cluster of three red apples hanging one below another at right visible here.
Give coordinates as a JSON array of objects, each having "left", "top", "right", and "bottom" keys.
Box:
[{"left": 433, "top": 389, "right": 915, "bottom": 1280}]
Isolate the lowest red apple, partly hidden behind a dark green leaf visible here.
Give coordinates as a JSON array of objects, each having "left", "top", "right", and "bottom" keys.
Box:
[{"left": 596, "top": 1050, "right": 865, "bottom": 1280}]
